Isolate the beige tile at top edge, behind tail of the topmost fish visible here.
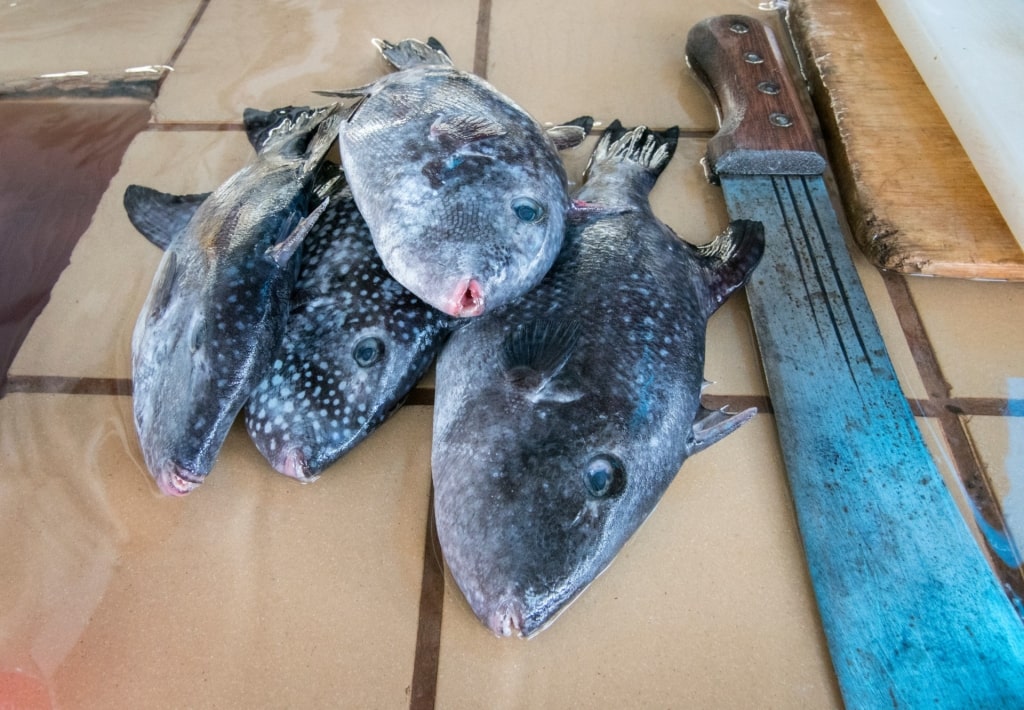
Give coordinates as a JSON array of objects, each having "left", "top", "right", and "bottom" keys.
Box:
[{"left": 156, "top": 0, "right": 477, "bottom": 121}]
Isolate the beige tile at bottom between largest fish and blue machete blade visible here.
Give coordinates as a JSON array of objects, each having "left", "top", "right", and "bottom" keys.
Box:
[{"left": 437, "top": 416, "right": 841, "bottom": 708}]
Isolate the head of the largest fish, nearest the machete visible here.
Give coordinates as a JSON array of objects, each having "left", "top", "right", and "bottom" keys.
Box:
[{"left": 433, "top": 393, "right": 678, "bottom": 637}]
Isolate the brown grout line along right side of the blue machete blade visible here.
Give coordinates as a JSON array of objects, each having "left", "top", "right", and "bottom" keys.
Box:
[{"left": 882, "top": 270, "right": 1024, "bottom": 610}]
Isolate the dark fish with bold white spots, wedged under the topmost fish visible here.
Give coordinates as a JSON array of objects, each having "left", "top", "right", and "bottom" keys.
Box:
[{"left": 246, "top": 162, "right": 452, "bottom": 483}]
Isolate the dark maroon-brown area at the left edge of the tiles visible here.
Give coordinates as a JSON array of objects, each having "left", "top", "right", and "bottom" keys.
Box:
[{"left": 0, "top": 99, "right": 150, "bottom": 386}]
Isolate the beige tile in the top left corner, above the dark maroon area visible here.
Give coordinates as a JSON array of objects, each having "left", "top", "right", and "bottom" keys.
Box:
[{"left": 0, "top": 0, "right": 200, "bottom": 82}]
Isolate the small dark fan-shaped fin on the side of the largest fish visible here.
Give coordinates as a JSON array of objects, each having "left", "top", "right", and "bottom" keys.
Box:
[{"left": 502, "top": 321, "right": 581, "bottom": 392}]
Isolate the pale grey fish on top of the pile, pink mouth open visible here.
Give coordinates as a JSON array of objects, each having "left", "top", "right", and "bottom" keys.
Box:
[{"left": 322, "top": 38, "right": 586, "bottom": 318}]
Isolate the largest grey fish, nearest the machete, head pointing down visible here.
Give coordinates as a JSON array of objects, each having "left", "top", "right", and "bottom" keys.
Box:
[{"left": 431, "top": 121, "right": 764, "bottom": 637}]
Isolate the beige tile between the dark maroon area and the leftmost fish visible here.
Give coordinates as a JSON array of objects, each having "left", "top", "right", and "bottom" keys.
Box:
[{"left": 10, "top": 131, "right": 252, "bottom": 377}]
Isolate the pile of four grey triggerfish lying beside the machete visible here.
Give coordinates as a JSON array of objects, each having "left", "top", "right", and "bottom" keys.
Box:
[{"left": 125, "top": 39, "right": 764, "bottom": 636}]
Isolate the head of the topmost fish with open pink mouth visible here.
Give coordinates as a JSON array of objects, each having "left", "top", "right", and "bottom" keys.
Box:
[{"left": 360, "top": 123, "right": 569, "bottom": 318}]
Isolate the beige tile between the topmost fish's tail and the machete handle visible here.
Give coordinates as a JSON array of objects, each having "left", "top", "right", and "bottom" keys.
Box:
[{"left": 487, "top": 0, "right": 768, "bottom": 130}]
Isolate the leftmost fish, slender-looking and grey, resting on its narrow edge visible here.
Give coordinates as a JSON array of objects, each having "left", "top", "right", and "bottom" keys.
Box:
[{"left": 124, "top": 105, "right": 340, "bottom": 496}]
